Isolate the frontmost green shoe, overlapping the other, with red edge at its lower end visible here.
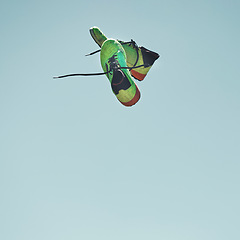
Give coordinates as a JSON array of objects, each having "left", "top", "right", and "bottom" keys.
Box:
[{"left": 100, "top": 39, "right": 140, "bottom": 106}]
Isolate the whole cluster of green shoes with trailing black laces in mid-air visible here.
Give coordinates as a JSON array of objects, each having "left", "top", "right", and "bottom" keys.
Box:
[{"left": 54, "top": 27, "right": 159, "bottom": 107}]
